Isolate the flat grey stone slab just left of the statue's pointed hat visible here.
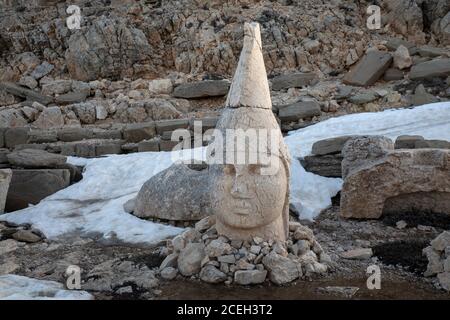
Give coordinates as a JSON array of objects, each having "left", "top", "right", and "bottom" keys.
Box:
[{"left": 173, "top": 80, "right": 230, "bottom": 99}]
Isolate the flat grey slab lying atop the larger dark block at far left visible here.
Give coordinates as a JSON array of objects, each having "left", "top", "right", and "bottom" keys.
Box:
[{"left": 7, "top": 149, "right": 67, "bottom": 168}]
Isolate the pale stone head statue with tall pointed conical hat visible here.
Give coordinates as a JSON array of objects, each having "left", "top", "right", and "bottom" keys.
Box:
[{"left": 210, "top": 23, "right": 290, "bottom": 241}]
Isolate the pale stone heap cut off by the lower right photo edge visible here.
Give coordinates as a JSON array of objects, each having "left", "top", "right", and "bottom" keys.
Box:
[{"left": 423, "top": 231, "right": 450, "bottom": 291}]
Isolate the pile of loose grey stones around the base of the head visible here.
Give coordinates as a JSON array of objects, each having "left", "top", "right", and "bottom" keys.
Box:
[{"left": 159, "top": 216, "right": 332, "bottom": 285}]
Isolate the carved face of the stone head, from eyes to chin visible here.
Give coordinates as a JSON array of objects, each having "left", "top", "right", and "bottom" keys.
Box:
[{"left": 211, "top": 156, "right": 287, "bottom": 229}]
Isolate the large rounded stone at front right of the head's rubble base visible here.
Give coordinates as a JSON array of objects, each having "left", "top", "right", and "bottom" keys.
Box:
[{"left": 262, "top": 251, "right": 302, "bottom": 285}]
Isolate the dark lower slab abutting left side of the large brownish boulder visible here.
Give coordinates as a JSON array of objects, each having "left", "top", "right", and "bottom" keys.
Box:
[{"left": 300, "top": 154, "right": 342, "bottom": 178}]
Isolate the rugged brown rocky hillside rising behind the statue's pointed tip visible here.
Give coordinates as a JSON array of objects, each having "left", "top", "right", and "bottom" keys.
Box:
[{"left": 0, "top": 0, "right": 450, "bottom": 81}]
